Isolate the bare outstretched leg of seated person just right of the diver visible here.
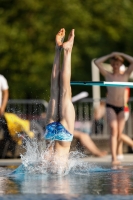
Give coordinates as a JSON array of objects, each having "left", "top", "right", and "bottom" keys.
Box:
[{"left": 73, "top": 130, "right": 107, "bottom": 157}]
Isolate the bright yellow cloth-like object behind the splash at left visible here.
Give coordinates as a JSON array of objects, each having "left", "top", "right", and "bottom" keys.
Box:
[{"left": 4, "top": 113, "right": 34, "bottom": 144}]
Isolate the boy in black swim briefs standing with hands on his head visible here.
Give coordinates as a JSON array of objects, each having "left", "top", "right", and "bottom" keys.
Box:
[{"left": 95, "top": 52, "right": 133, "bottom": 164}]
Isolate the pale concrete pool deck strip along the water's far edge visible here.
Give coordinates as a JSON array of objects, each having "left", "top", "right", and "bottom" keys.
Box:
[{"left": 0, "top": 154, "right": 133, "bottom": 166}]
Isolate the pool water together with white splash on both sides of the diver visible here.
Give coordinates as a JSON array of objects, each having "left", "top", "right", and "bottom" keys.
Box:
[{"left": 0, "top": 138, "right": 133, "bottom": 200}]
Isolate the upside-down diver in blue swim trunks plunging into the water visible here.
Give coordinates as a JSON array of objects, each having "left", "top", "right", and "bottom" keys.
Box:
[{"left": 44, "top": 28, "right": 75, "bottom": 168}]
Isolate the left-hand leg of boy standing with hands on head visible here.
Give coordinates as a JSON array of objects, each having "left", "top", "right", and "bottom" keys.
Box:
[{"left": 107, "top": 108, "right": 119, "bottom": 164}]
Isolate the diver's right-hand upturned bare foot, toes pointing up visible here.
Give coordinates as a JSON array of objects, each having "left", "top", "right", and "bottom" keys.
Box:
[{"left": 62, "top": 29, "right": 75, "bottom": 50}]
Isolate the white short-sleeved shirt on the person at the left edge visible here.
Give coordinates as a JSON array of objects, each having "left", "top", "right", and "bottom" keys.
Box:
[{"left": 0, "top": 74, "right": 9, "bottom": 106}]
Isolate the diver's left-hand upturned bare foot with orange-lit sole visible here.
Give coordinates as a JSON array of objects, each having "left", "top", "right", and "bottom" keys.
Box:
[{"left": 55, "top": 28, "right": 65, "bottom": 49}]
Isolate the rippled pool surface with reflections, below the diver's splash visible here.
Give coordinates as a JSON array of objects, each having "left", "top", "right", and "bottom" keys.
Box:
[{"left": 0, "top": 164, "right": 133, "bottom": 200}]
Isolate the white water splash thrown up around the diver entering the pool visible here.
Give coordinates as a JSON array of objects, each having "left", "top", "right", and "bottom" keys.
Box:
[{"left": 12, "top": 138, "right": 115, "bottom": 176}]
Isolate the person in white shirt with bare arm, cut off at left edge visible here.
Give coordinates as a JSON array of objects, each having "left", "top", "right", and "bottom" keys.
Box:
[{"left": 0, "top": 74, "right": 9, "bottom": 116}]
